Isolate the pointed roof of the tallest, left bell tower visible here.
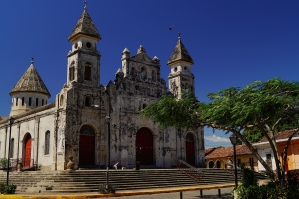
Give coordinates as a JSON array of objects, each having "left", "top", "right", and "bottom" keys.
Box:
[{"left": 68, "top": 7, "right": 102, "bottom": 41}]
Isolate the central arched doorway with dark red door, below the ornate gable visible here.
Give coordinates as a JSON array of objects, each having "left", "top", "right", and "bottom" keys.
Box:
[{"left": 136, "top": 127, "right": 153, "bottom": 165}]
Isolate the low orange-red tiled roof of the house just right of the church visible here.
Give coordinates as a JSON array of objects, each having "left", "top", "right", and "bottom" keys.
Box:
[{"left": 206, "top": 144, "right": 252, "bottom": 159}]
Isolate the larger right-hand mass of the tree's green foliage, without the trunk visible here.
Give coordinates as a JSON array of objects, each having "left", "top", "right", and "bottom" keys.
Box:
[{"left": 201, "top": 78, "right": 299, "bottom": 131}]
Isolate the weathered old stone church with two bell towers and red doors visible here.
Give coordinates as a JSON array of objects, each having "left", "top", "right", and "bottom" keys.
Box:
[{"left": 0, "top": 6, "right": 205, "bottom": 171}]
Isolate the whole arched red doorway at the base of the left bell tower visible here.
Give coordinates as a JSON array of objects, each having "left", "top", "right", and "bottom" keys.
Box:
[{"left": 79, "top": 125, "right": 95, "bottom": 166}]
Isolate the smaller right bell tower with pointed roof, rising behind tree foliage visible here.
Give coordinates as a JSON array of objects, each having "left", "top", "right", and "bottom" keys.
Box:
[{"left": 167, "top": 33, "right": 195, "bottom": 99}]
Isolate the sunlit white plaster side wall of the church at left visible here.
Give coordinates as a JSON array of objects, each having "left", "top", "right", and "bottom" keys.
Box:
[{"left": 0, "top": 106, "right": 55, "bottom": 170}]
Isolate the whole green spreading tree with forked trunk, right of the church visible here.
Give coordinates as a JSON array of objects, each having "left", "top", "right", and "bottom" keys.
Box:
[{"left": 140, "top": 78, "right": 299, "bottom": 183}]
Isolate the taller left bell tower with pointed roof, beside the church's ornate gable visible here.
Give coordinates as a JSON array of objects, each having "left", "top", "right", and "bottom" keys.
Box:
[{"left": 67, "top": 4, "right": 102, "bottom": 86}]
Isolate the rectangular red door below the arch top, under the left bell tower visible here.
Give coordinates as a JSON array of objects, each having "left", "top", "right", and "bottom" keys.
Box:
[{"left": 79, "top": 135, "right": 95, "bottom": 165}]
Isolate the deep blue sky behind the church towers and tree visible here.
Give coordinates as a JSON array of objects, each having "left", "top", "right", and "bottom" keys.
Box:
[{"left": 0, "top": 0, "right": 299, "bottom": 147}]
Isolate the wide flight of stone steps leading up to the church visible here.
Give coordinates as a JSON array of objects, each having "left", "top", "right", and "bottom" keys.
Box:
[{"left": 0, "top": 168, "right": 267, "bottom": 193}]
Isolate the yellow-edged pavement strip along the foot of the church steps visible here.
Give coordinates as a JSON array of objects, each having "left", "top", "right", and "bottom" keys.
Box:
[{"left": 0, "top": 183, "right": 234, "bottom": 199}]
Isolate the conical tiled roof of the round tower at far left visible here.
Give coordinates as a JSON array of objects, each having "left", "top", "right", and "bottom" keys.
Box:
[{"left": 9, "top": 61, "right": 51, "bottom": 97}]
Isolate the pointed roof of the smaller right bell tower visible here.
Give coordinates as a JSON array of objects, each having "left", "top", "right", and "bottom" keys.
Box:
[{"left": 167, "top": 36, "right": 194, "bottom": 65}]
